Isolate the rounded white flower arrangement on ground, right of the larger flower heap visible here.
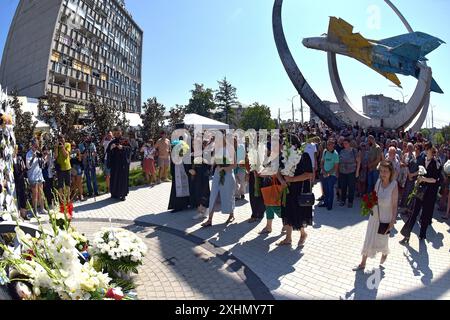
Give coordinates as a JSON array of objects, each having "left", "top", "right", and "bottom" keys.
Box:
[{"left": 92, "top": 227, "right": 147, "bottom": 278}]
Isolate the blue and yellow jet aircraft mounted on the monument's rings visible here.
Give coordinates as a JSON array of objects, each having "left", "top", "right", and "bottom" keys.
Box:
[{"left": 303, "top": 17, "right": 445, "bottom": 93}]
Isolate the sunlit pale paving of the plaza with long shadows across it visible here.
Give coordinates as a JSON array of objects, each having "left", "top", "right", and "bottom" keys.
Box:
[{"left": 53, "top": 184, "right": 450, "bottom": 299}]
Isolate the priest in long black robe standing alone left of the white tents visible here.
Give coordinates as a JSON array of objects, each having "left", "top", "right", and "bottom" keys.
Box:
[{"left": 106, "top": 128, "right": 131, "bottom": 201}]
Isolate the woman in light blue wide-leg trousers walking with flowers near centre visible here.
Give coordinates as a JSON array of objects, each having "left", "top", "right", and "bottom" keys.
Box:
[{"left": 202, "top": 139, "right": 237, "bottom": 228}]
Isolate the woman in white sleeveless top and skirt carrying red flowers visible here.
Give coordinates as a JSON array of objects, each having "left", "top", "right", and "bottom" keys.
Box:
[{"left": 353, "top": 161, "right": 398, "bottom": 271}]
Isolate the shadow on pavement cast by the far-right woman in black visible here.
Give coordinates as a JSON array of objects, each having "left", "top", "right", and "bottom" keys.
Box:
[{"left": 404, "top": 241, "right": 433, "bottom": 286}]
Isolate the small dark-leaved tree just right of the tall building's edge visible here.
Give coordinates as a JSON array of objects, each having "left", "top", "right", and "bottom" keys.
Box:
[{"left": 141, "top": 97, "right": 166, "bottom": 140}]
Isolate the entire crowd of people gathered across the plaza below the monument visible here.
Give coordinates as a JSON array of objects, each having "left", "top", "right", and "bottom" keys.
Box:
[{"left": 9, "top": 122, "right": 450, "bottom": 270}]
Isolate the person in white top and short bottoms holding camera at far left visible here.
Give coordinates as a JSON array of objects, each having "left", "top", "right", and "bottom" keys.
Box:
[{"left": 26, "top": 138, "right": 47, "bottom": 214}]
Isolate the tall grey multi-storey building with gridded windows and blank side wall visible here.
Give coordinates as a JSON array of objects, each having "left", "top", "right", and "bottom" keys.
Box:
[{"left": 0, "top": 0, "right": 143, "bottom": 112}]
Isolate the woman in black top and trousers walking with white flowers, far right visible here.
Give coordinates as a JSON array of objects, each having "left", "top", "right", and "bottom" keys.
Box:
[{"left": 400, "top": 142, "right": 442, "bottom": 245}]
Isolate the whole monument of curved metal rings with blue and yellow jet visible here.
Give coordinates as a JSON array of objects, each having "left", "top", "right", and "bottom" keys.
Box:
[{"left": 272, "top": 0, "right": 444, "bottom": 130}]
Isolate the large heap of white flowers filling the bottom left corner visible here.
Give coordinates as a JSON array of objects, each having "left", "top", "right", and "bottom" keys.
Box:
[{"left": 0, "top": 227, "right": 117, "bottom": 300}]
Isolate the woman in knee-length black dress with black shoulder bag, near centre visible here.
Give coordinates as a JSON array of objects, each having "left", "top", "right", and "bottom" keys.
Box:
[{"left": 278, "top": 136, "right": 313, "bottom": 247}]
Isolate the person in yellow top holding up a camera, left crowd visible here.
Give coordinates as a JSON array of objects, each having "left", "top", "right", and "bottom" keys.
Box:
[{"left": 54, "top": 134, "right": 72, "bottom": 198}]
